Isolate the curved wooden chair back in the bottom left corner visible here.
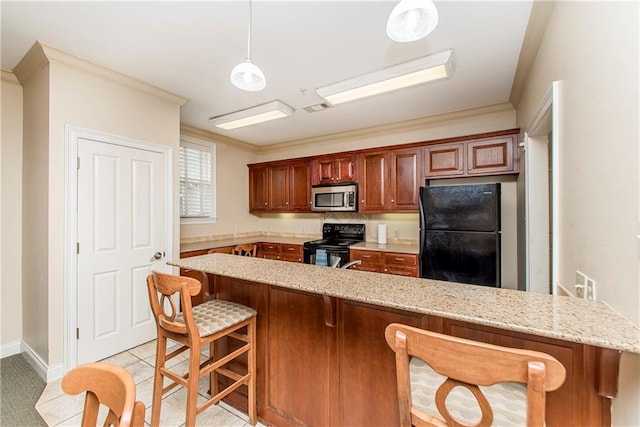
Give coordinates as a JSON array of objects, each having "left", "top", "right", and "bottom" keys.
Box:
[{"left": 62, "top": 363, "right": 144, "bottom": 427}]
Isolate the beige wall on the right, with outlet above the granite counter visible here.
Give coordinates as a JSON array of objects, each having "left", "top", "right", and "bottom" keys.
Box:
[{"left": 517, "top": 2, "right": 640, "bottom": 426}]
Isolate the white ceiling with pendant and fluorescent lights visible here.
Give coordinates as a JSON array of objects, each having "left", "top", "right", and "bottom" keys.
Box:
[{"left": 1, "top": 0, "right": 532, "bottom": 146}]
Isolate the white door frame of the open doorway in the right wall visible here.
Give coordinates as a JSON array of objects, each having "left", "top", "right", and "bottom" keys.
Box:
[{"left": 525, "top": 81, "right": 562, "bottom": 295}]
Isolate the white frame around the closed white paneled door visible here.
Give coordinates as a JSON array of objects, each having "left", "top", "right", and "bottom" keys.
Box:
[{"left": 63, "top": 125, "right": 174, "bottom": 372}]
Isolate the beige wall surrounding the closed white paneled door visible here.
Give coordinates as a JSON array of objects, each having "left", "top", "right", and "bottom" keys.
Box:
[{"left": 16, "top": 41, "right": 183, "bottom": 376}]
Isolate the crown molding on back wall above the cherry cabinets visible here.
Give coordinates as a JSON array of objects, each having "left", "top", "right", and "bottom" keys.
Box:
[{"left": 257, "top": 102, "right": 514, "bottom": 154}]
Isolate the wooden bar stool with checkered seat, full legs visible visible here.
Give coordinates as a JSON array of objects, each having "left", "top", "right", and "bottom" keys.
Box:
[{"left": 147, "top": 271, "right": 257, "bottom": 427}]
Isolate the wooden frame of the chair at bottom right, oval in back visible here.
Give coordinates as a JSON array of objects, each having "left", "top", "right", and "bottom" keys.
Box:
[{"left": 385, "top": 323, "right": 566, "bottom": 427}]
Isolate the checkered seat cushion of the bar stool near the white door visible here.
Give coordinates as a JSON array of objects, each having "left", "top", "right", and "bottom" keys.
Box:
[{"left": 176, "top": 299, "right": 256, "bottom": 337}]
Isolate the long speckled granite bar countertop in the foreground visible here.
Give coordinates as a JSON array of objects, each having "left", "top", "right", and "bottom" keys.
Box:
[{"left": 168, "top": 254, "right": 640, "bottom": 354}]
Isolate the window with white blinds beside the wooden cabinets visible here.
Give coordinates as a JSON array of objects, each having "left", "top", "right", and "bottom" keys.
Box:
[{"left": 179, "top": 140, "right": 215, "bottom": 219}]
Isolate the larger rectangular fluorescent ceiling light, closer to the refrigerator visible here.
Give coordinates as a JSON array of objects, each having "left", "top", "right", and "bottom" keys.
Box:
[{"left": 316, "top": 49, "right": 454, "bottom": 105}]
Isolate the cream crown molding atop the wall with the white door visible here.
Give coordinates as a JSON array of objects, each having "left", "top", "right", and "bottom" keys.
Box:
[{"left": 14, "top": 41, "right": 188, "bottom": 106}]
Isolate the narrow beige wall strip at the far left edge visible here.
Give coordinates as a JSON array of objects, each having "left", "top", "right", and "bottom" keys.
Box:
[{"left": 0, "top": 71, "right": 22, "bottom": 357}]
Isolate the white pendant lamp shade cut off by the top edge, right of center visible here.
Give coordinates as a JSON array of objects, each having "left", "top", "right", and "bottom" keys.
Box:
[{"left": 387, "top": 0, "right": 438, "bottom": 43}]
